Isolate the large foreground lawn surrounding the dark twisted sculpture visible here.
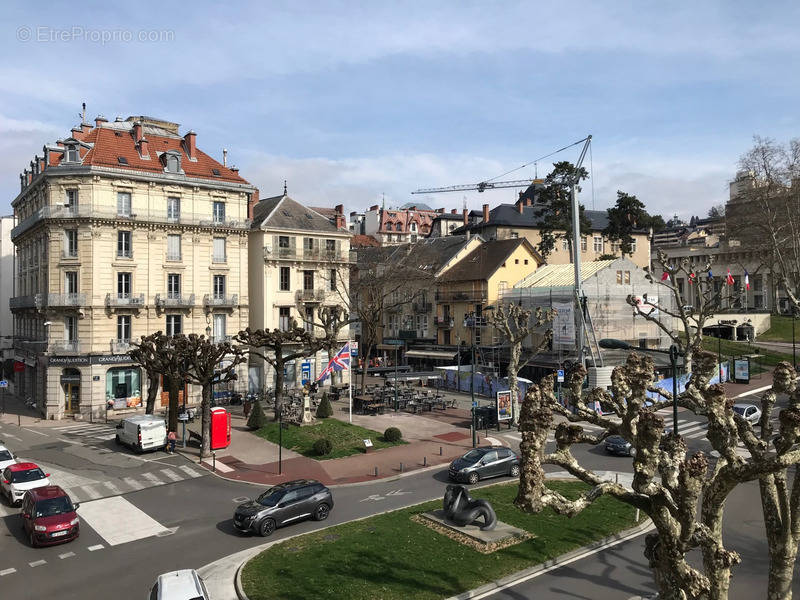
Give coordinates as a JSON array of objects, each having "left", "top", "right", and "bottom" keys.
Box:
[{"left": 242, "top": 482, "right": 635, "bottom": 600}]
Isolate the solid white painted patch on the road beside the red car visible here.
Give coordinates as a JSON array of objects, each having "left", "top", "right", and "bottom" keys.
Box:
[{"left": 80, "top": 496, "right": 169, "bottom": 546}]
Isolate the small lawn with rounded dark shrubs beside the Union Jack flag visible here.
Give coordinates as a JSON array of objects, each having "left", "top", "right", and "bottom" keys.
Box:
[{"left": 255, "top": 418, "right": 407, "bottom": 460}]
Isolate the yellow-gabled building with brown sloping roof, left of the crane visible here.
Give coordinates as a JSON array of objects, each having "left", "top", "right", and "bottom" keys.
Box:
[{"left": 434, "top": 238, "right": 543, "bottom": 346}]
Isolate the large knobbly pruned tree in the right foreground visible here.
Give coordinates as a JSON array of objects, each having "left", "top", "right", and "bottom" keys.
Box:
[{"left": 515, "top": 352, "right": 800, "bottom": 600}]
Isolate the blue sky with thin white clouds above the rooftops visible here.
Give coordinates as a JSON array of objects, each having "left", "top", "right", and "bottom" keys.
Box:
[{"left": 0, "top": 0, "right": 800, "bottom": 218}]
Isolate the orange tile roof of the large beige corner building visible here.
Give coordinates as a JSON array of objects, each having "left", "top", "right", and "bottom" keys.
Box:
[{"left": 50, "top": 127, "right": 249, "bottom": 184}]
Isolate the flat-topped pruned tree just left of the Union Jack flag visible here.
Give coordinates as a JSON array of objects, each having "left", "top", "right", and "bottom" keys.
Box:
[{"left": 234, "top": 319, "right": 325, "bottom": 421}]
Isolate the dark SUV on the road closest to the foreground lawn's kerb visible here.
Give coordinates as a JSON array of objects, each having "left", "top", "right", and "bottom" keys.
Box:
[{"left": 233, "top": 479, "right": 333, "bottom": 536}]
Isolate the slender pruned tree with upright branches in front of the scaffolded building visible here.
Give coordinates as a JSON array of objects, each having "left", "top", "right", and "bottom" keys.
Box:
[{"left": 489, "top": 302, "right": 555, "bottom": 425}]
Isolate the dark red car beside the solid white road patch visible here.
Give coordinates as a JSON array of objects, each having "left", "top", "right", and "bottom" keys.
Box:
[{"left": 22, "top": 485, "right": 80, "bottom": 547}]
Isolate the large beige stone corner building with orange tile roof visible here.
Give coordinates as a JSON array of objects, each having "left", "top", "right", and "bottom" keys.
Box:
[{"left": 10, "top": 117, "right": 258, "bottom": 420}]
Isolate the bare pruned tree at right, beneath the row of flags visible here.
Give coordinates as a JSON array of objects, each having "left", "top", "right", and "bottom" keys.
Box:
[{"left": 627, "top": 250, "right": 723, "bottom": 372}]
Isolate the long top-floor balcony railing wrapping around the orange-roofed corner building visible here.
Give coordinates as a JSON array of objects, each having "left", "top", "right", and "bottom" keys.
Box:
[{"left": 11, "top": 205, "right": 251, "bottom": 240}]
